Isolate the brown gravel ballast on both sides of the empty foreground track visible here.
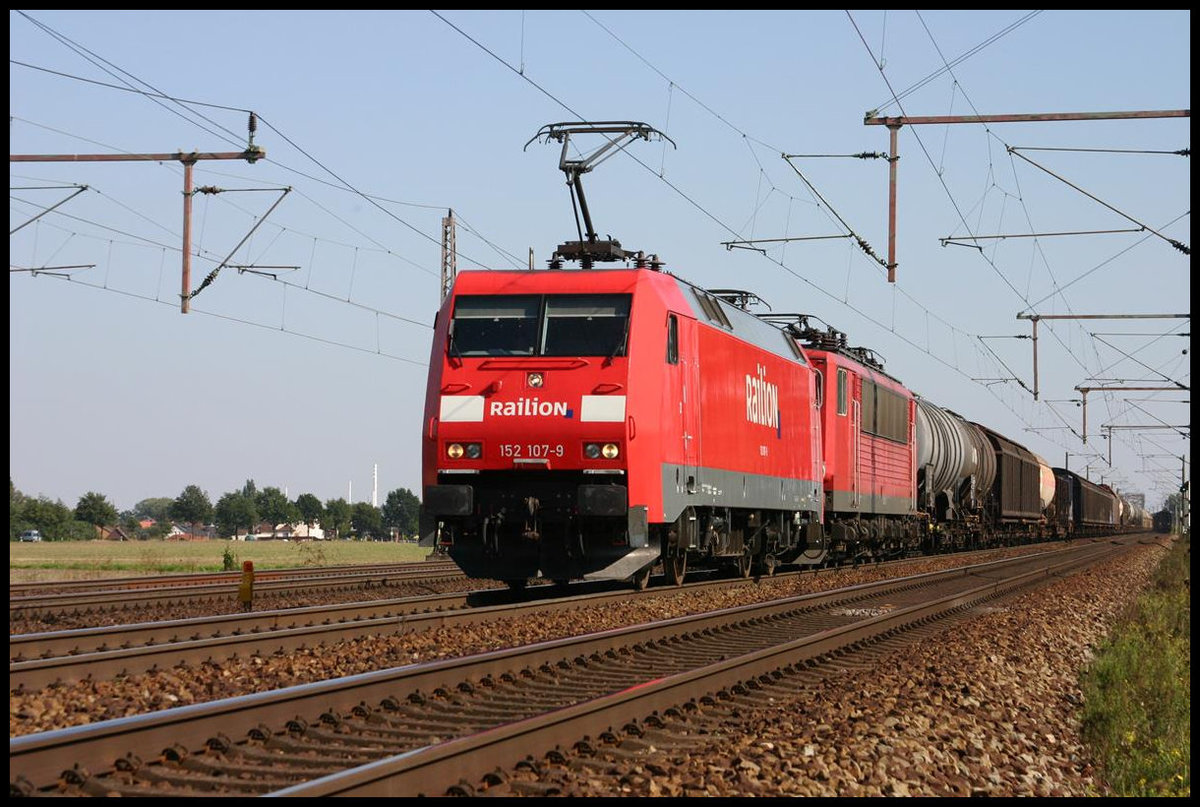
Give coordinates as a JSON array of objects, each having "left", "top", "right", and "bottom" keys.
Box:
[{"left": 8, "top": 544, "right": 1166, "bottom": 796}]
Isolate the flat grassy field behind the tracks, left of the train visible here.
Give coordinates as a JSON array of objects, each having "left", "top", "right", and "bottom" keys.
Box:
[{"left": 8, "top": 540, "right": 430, "bottom": 582}]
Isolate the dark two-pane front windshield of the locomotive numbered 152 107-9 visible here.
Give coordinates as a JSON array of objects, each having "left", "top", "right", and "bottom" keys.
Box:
[{"left": 446, "top": 294, "right": 631, "bottom": 358}]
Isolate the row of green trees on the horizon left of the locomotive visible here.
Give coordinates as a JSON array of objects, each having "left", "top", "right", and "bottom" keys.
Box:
[{"left": 8, "top": 477, "right": 421, "bottom": 540}]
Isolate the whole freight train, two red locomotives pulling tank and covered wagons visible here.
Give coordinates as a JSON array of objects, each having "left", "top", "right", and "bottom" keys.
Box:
[{"left": 420, "top": 120, "right": 1144, "bottom": 588}]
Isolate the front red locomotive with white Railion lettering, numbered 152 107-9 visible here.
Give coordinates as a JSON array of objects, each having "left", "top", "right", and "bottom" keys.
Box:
[{"left": 421, "top": 264, "right": 823, "bottom": 587}]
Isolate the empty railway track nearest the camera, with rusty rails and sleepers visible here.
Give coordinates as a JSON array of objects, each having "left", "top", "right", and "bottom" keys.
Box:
[{"left": 10, "top": 542, "right": 1126, "bottom": 796}]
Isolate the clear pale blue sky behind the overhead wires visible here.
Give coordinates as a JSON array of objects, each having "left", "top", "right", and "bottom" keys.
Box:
[{"left": 8, "top": 10, "right": 1192, "bottom": 509}]
